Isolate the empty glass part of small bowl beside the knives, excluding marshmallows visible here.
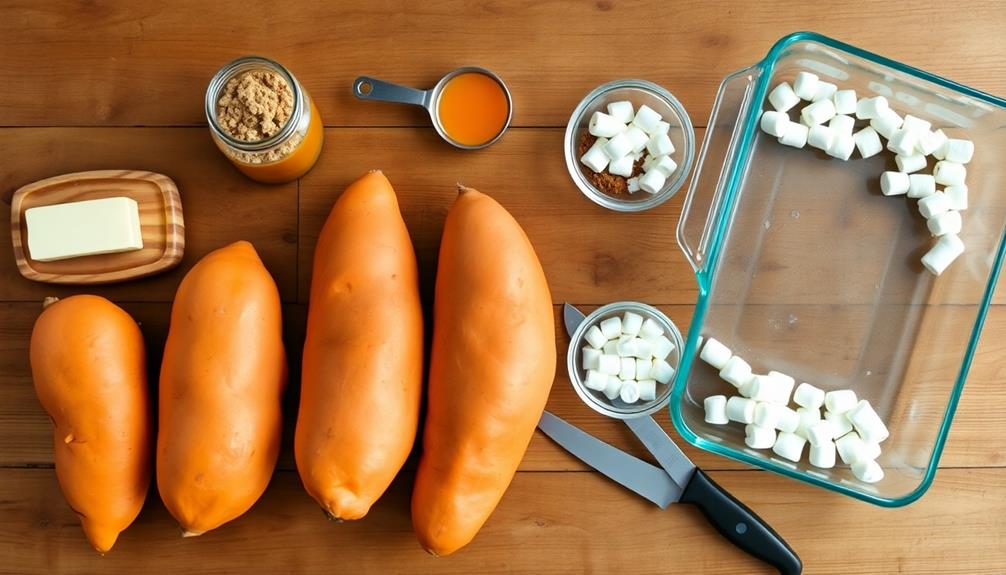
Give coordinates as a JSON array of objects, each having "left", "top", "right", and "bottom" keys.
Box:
[{"left": 566, "top": 302, "right": 682, "bottom": 419}]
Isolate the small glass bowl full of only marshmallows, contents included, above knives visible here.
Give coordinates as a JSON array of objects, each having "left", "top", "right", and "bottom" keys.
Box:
[{"left": 566, "top": 302, "right": 681, "bottom": 418}]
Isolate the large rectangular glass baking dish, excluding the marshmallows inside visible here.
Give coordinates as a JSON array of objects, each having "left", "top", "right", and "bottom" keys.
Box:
[{"left": 671, "top": 32, "right": 1006, "bottom": 507}]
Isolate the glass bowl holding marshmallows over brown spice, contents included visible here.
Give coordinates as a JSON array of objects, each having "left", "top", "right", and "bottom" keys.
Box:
[{"left": 564, "top": 79, "right": 695, "bottom": 212}]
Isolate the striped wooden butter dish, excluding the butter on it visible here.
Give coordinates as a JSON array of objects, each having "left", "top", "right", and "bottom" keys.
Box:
[{"left": 10, "top": 170, "right": 185, "bottom": 284}]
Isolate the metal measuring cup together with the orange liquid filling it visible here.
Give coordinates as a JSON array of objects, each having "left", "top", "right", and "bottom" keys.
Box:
[{"left": 353, "top": 66, "right": 513, "bottom": 150}]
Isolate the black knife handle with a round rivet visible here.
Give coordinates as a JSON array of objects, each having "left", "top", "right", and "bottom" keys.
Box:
[{"left": 680, "top": 469, "right": 804, "bottom": 575}]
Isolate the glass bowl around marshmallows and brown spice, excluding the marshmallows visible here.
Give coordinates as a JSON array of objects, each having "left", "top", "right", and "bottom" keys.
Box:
[{"left": 565, "top": 79, "right": 695, "bottom": 212}]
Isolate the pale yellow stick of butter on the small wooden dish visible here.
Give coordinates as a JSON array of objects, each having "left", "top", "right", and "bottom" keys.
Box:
[{"left": 24, "top": 197, "right": 143, "bottom": 261}]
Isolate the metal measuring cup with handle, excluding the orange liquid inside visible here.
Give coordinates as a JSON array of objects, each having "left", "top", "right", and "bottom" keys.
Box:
[{"left": 353, "top": 66, "right": 513, "bottom": 150}]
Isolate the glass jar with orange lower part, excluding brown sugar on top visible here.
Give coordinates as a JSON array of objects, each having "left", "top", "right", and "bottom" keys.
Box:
[{"left": 205, "top": 56, "right": 324, "bottom": 184}]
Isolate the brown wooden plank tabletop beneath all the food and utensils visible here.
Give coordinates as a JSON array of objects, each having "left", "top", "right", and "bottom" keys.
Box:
[{"left": 0, "top": 0, "right": 1006, "bottom": 574}]
